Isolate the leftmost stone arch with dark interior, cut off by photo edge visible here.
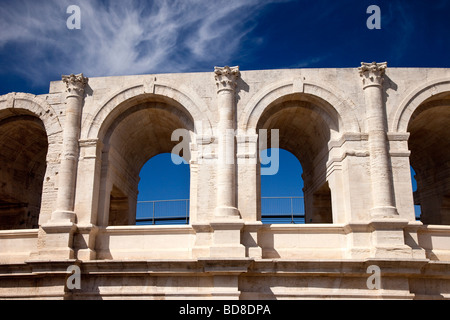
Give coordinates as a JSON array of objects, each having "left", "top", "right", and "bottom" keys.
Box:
[{"left": 0, "top": 93, "right": 62, "bottom": 229}]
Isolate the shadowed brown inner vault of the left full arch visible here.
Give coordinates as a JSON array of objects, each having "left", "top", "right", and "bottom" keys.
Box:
[{"left": 99, "top": 96, "right": 193, "bottom": 226}]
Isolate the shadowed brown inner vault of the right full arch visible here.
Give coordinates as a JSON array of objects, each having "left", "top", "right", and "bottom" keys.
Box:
[{"left": 257, "top": 94, "right": 339, "bottom": 223}]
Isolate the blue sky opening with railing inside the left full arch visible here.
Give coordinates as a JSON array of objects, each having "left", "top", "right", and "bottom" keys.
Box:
[{"left": 136, "top": 153, "right": 190, "bottom": 225}]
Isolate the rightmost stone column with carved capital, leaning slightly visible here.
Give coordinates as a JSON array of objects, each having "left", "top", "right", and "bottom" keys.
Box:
[{"left": 359, "top": 62, "right": 398, "bottom": 217}]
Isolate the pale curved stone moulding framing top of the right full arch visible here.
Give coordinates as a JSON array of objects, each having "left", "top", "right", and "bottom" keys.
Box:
[{"left": 239, "top": 79, "right": 361, "bottom": 136}]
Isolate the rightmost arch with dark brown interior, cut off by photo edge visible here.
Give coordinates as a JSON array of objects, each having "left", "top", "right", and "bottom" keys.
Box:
[{"left": 390, "top": 78, "right": 450, "bottom": 225}]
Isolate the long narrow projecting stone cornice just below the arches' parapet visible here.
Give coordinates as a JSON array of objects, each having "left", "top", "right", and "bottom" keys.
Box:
[{"left": 0, "top": 258, "right": 438, "bottom": 278}]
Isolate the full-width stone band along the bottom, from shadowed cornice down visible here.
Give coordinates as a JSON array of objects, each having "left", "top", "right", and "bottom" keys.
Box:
[{"left": 0, "top": 258, "right": 450, "bottom": 299}]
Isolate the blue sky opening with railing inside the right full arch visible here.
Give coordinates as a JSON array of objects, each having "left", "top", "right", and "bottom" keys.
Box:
[{"left": 261, "top": 149, "right": 305, "bottom": 224}]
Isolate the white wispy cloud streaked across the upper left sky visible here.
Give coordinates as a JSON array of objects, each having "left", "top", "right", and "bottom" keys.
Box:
[{"left": 0, "top": 0, "right": 283, "bottom": 85}]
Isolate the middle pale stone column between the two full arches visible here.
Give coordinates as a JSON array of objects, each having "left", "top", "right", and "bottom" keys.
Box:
[{"left": 214, "top": 67, "right": 240, "bottom": 218}]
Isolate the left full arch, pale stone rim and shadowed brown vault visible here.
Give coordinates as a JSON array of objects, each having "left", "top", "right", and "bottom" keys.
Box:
[{"left": 92, "top": 82, "right": 212, "bottom": 226}]
